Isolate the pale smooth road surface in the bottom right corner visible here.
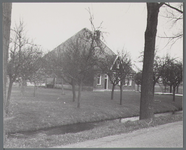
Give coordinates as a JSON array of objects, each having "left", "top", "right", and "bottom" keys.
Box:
[{"left": 55, "top": 121, "right": 183, "bottom": 148}]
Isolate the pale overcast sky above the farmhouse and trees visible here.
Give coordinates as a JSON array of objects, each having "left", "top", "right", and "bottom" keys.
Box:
[{"left": 11, "top": 3, "right": 183, "bottom": 70}]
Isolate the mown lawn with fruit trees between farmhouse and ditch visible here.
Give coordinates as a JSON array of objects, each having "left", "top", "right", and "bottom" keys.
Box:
[{"left": 4, "top": 87, "right": 182, "bottom": 133}]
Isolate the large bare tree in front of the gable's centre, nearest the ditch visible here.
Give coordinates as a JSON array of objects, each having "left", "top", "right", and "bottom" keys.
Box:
[{"left": 62, "top": 29, "right": 101, "bottom": 108}]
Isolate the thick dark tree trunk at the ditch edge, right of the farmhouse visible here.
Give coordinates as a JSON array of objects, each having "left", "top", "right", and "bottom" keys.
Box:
[{"left": 140, "top": 3, "right": 160, "bottom": 120}]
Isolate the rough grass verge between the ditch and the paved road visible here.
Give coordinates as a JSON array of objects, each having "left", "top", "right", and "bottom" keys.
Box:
[{"left": 4, "top": 114, "right": 183, "bottom": 148}]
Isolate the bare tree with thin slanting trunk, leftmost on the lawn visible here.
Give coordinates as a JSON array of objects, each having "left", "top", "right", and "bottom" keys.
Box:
[{"left": 5, "top": 22, "right": 42, "bottom": 114}]
